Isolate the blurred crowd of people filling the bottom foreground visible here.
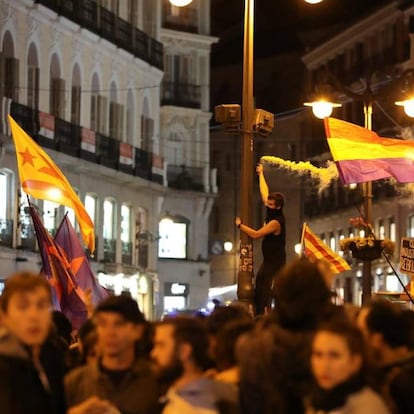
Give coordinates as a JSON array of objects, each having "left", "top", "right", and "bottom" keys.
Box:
[{"left": 0, "top": 258, "right": 414, "bottom": 414}]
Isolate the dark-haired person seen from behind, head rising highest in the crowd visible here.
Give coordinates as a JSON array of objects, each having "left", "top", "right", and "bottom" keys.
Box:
[{"left": 236, "top": 258, "right": 342, "bottom": 414}]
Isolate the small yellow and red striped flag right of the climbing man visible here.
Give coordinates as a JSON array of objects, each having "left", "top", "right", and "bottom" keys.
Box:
[{"left": 302, "top": 223, "right": 351, "bottom": 273}]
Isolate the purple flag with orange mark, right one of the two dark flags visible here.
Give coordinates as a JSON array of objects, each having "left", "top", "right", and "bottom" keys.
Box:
[{"left": 55, "top": 214, "right": 109, "bottom": 306}]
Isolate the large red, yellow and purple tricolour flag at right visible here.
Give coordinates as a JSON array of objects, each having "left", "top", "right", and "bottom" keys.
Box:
[{"left": 325, "top": 118, "right": 414, "bottom": 184}]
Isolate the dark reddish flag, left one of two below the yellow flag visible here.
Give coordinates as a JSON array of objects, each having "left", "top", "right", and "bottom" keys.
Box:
[{"left": 29, "top": 206, "right": 88, "bottom": 329}]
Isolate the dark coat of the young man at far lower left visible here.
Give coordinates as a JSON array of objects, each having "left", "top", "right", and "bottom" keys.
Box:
[{"left": 0, "top": 332, "right": 64, "bottom": 414}]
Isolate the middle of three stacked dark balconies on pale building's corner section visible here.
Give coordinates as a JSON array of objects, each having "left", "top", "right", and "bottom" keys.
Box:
[{"left": 161, "top": 82, "right": 201, "bottom": 109}]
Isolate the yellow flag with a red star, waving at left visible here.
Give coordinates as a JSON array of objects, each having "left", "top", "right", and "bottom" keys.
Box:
[{"left": 9, "top": 115, "right": 95, "bottom": 252}]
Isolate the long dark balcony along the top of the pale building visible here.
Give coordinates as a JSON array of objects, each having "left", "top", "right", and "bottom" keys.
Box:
[{"left": 35, "top": 0, "right": 164, "bottom": 70}]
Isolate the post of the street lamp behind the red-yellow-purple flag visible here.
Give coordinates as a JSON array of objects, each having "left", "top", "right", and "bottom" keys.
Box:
[{"left": 362, "top": 98, "right": 372, "bottom": 304}]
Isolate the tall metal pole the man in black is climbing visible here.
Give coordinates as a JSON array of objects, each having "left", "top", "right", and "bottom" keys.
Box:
[{"left": 237, "top": 0, "right": 254, "bottom": 304}]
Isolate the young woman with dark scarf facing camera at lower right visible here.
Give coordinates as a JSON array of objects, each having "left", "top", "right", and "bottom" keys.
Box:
[{"left": 306, "top": 317, "right": 390, "bottom": 414}]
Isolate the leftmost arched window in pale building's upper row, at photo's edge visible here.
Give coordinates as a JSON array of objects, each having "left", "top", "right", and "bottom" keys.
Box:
[{"left": 0, "top": 32, "right": 19, "bottom": 101}]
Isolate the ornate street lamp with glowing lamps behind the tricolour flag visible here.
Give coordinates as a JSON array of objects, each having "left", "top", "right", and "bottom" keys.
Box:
[{"left": 304, "top": 69, "right": 414, "bottom": 304}]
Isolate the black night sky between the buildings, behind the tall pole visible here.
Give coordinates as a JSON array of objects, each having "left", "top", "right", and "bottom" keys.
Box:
[{"left": 210, "top": 0, "right": 398, "bottom": 113}]
